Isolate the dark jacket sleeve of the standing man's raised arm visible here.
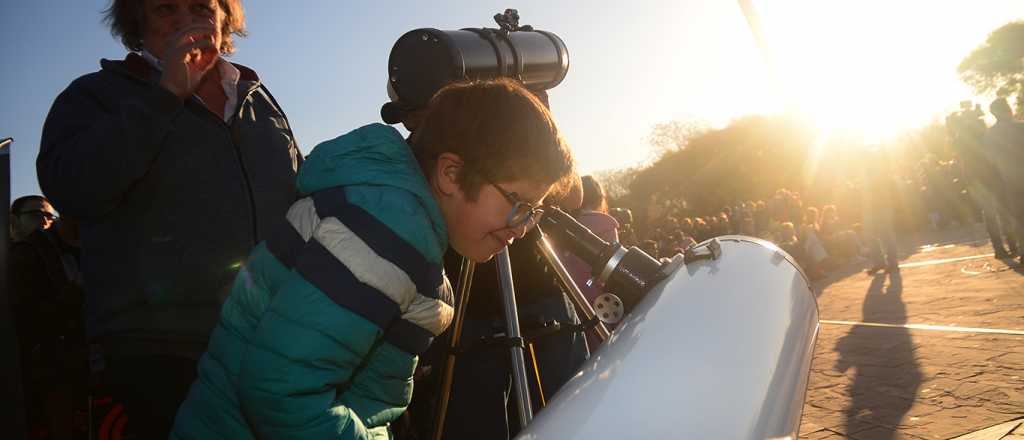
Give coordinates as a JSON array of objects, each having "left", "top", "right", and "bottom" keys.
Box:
[{"left": 36, "top": 74, "right": 183, "bottom": 217}]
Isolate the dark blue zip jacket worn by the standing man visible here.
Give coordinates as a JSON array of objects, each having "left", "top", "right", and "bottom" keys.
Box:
[{"left": 36, "top": 54, "right": 302, "bottom": 358}]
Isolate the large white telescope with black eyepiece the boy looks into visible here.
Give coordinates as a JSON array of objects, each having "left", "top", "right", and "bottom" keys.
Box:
[{"left": 516, "top": 209, "right": 818, "bottom": 440}]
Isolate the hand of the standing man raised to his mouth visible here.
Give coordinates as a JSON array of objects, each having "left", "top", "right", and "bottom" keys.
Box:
[{"left": 160, "top": 23, "right": 220, "bottom": 99}]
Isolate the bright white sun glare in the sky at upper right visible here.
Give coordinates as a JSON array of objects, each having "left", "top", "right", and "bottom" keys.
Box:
[{"left": 756, "top": 1, "right": 990, "bottom": 143}]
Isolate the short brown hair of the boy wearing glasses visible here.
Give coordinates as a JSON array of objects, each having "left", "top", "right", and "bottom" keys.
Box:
[{"left": 410, "top": 78, "right": 573, "bottom": 200}]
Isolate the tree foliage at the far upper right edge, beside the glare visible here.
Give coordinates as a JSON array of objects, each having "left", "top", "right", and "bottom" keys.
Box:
[{"left": 956, "top": 20, "right": 1024, "bottom": 113}]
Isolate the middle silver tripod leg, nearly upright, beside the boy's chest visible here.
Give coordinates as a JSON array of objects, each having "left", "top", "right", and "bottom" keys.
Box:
[{"left": 497, "top": 248, "right": 534, "bottom": 428}]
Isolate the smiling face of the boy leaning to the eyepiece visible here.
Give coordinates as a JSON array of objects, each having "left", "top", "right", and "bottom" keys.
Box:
[{"left": 432, "top": 153, "right": 551, "bottom": 263}]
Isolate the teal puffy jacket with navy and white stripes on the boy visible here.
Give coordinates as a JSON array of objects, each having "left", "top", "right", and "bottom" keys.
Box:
[{"left": 171, "top": 124, "right": 453, "bottom": 439}]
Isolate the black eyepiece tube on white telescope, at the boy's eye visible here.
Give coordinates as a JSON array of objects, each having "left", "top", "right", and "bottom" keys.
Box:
[{"left": 540, "top": 207, "right": 664, "bottom": 302}]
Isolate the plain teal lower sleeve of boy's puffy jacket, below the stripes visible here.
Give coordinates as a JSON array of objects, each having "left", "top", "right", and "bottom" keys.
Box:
[{"left": 238, "top": 277, "right": 381, "bottom": 440}]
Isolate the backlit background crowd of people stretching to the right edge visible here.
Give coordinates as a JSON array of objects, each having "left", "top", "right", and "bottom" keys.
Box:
[{"left": 610, "top": 98, "right": 1024, "bottom": 278}]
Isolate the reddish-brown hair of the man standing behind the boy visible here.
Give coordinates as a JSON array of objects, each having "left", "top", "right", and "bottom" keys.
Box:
[{"left": 103, "top": 0, "right": 246, "bottom": 55}]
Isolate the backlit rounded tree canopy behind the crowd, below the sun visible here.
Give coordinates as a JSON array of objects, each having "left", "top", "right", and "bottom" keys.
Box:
[{"left": 618, "top": 116, "right": 949, "bottom": 222}]
